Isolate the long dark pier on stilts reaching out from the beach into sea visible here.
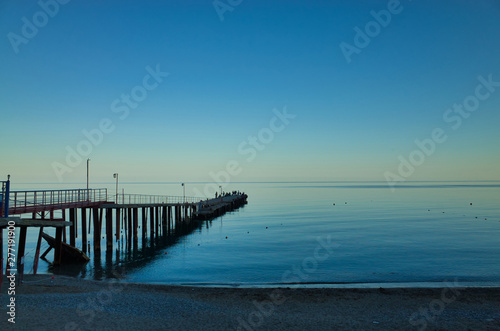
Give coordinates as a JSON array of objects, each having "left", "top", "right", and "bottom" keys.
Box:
[{"left": 0, "top": 181, "right": 247, "bottom": 284}]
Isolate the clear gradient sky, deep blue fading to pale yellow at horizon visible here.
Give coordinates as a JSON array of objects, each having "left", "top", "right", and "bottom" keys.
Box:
[{"left": 0, "top": 0, "right": 500, "bottom": 187}]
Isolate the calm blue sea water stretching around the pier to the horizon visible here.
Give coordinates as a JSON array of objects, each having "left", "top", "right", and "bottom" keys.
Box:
[{"left": 3, "top": 182, "right": 500, "bottom": 285}]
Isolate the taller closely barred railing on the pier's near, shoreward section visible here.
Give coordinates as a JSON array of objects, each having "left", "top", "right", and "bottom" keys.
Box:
[{"left": 9, "top": 189, "right": 108, "bottom": 214}]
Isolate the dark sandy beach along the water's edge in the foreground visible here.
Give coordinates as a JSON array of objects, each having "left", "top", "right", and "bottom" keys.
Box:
[{"left": 0, "top": 275, "right": 500, "bottom": 330}]
